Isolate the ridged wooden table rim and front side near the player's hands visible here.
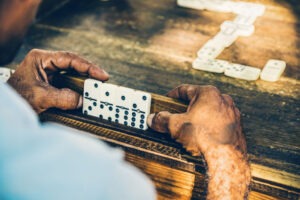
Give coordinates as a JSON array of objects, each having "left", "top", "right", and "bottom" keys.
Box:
[{"left": 41, "top": 73, "right": 300, "bottom": 199}]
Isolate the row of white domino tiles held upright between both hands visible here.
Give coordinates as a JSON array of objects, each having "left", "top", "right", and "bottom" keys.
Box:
[{"left": 82, "top": 79, "right": 151, "bottom": 130}]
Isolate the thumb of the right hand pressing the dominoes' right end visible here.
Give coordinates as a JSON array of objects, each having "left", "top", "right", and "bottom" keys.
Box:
[{"left": 147, "top": 111, "right": 188, "bottom": 139}]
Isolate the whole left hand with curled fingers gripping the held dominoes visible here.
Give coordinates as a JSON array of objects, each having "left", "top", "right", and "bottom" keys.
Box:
[{"left": 8, "top": 49, "right": 109, "bottom": 113}]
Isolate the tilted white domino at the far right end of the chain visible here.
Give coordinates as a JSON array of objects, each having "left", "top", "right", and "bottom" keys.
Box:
[{"left": 260, "top": 59, "right": 286, "bottom": 82}]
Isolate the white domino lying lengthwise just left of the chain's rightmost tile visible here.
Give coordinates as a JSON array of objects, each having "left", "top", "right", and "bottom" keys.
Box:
[{"left": 224, "top": 64, "right": 261, "bottom": 81}]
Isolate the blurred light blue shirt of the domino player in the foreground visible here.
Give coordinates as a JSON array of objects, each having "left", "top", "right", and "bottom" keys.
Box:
[{"left": 0, "top": 84, "right": 155, "bottom": 200}]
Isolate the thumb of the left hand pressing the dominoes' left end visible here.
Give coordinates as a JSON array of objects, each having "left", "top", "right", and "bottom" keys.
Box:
[{"left": 43, "top": 86, "right": 83, "bottom": 110}]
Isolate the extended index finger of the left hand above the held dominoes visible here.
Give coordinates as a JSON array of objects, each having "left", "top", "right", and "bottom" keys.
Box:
[{"left": 35, "top": 50, "right": 109, "bottom": 81}]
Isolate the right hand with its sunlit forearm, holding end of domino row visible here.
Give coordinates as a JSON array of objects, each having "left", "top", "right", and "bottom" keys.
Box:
[{"left": 148, "top": 85, "right": 251, "bottom": 200}]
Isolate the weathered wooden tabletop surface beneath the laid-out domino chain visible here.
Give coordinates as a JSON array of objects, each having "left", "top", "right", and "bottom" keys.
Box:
[{"left": 3, "top": 0, "right": 300, "bottom": 198}]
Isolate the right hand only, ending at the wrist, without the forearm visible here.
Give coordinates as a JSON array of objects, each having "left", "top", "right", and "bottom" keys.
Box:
[{"left": 148, "top": 85, "right": 246, "bottom": 156}]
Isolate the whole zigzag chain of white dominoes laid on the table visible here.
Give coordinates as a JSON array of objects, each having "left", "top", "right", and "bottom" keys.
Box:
[{"left": 177, "top": 0, "right": 286, "bottom": 81}]
